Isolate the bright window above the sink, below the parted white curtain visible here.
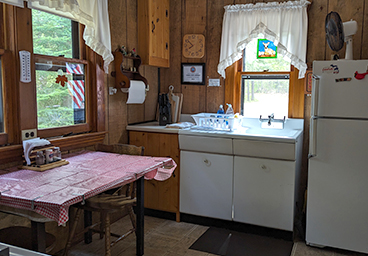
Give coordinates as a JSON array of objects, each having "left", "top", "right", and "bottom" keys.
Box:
[{"left": 240, "top": 38, "right": 290, "bottom": 119}]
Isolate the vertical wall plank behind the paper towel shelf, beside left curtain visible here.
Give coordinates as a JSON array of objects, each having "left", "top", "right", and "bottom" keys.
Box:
[{"left": 106, "top": 0, "right": 128, "bottom": 144}]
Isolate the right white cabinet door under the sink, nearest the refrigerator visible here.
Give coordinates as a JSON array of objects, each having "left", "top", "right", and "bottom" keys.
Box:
[{"left": 234, "top": 156, "right": 295, "bottom": 231}]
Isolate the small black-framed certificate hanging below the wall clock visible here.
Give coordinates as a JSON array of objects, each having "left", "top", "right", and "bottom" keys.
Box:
[{"left": 181, "top": 63, "right": 206, "bottom": 85}]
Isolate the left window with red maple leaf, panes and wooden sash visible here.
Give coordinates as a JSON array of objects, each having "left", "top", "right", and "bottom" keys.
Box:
[{"left": 32, "top": 9, "right": 90, "bottom": 136}]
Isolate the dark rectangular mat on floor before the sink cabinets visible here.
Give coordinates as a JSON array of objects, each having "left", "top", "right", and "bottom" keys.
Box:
[{"left": 190, "top": 227, "right": 293, "bottom": 256}]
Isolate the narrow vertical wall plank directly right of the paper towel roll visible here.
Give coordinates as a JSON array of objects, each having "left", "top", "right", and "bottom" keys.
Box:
[{"left": 144, "top": 66, "right": 158, "bottom": 121}]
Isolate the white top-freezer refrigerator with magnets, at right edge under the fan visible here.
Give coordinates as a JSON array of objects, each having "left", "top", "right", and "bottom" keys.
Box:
[{"left": 306, "top": 60, "right": 368, "bottom": 253}]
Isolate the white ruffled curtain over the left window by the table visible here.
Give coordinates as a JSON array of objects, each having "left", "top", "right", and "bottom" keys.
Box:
[{"left": 0, "top": 0, "right": 114, "bottom": 73}]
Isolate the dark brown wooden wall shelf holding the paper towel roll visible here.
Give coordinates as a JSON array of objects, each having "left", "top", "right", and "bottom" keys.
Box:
[{"left": 111, "top": 48, "right": 149, "bottom": 92}]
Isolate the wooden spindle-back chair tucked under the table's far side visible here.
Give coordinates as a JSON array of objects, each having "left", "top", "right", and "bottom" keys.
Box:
[{"left": 64, "top": 144, "right": 144, "bottom": 256}]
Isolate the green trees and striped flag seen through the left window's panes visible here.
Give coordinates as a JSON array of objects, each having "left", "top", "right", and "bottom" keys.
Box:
[{"left": 32, "top": 10, "right": 85, "bottom": 129}]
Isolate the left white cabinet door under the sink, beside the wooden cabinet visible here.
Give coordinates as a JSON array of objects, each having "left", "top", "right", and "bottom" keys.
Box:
[{"left": 180, "top": 150, "right": 233, "bottom": 220}]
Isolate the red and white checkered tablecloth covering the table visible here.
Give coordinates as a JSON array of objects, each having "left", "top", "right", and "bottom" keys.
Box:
[{"left": 0, "top": 151, "right": 176, "bottom": 225}]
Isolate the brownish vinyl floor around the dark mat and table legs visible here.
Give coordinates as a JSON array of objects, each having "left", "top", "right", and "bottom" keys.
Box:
[{"left": 58, "top": 216, "right": 368, "bottom": 256}]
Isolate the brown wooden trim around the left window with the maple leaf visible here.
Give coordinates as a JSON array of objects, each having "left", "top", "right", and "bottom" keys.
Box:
[{"left": 0, "top": 3, "right": 107, "bottom": 165}]
